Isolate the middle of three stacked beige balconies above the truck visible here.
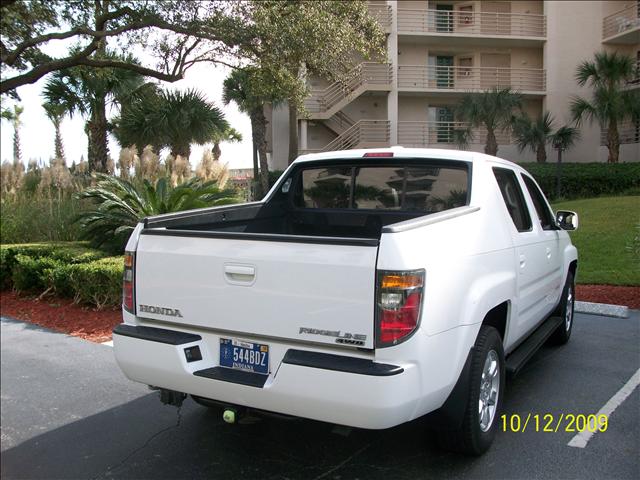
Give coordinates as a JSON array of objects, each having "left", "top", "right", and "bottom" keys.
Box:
[{"left": 398, "top": 65, "right": 546, "bottom": 95}]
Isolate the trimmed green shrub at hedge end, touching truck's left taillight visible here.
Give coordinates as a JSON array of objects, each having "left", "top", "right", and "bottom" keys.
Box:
[{"left": 68, "top": 257, "right": 124, "bottom": 308}]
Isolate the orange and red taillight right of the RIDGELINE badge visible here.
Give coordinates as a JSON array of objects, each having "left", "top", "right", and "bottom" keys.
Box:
[{"left": 376, "top": 270, "right": 424, "bottom": 347}]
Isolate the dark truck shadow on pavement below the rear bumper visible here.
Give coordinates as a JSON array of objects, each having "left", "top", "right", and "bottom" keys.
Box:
[{"left": 2, "top": 393, "right": 470, "bottom": 479}]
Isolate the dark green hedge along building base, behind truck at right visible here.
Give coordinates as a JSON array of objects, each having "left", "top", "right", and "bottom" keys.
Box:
[{"left": 520, "top": 161, "right": 640, "bottom": 199}]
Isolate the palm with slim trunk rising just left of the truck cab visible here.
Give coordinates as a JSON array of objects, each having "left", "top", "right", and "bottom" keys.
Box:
[{"left": 222, "top": 69, "right": 269, "bottom": 198}]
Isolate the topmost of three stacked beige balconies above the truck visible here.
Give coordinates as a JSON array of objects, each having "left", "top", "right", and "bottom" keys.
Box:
[{"left": 398, "top": 8, "right": 547, "bottom": 45}]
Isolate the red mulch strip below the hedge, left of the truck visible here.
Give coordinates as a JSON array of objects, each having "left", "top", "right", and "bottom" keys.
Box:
[{"left": 0, "top": 291, "right": 122, "bottom": 343}]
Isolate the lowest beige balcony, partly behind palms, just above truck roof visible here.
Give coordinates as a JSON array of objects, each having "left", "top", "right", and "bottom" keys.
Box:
[{"left": 398, "top": 121, "right": 512, "bottom": 148}]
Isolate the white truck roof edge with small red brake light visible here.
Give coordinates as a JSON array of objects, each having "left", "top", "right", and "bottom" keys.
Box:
[{"left": 295, "top": 146, "right": 517, "bottom": 167}]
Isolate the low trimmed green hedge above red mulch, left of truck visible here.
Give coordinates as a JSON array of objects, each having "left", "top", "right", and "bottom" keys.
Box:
[{"left": 0, "top": 243, "right": 123, "bottom": 308}]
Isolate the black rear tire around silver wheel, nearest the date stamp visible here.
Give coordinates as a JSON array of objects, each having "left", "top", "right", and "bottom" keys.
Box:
[{"left": 438, "top": 326, "right": 505, "bottom": 455}]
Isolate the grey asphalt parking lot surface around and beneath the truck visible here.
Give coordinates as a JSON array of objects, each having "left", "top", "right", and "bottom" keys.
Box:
[{"left": 1, "top": 311, "right": 640, "bottom": 480}]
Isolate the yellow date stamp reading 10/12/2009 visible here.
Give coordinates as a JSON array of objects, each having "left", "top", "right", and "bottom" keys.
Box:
[{"left": 500, "top": 413, "right": 609, "bottom": 433}]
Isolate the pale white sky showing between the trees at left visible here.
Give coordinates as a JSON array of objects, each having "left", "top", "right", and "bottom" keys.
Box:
[{"left": 0, "top": 57, "right": 252, "bottom": 168}]
